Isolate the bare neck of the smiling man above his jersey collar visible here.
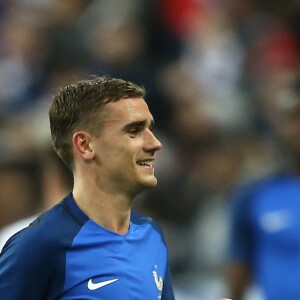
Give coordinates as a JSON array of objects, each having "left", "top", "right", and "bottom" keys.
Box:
[{"left": 73, "top": 178, "right": 133, "bottom": 234}]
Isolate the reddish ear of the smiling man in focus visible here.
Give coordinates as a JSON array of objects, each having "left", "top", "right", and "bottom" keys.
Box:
[{"left": 72, "top": 131, "right": 95, "bottom": 160}]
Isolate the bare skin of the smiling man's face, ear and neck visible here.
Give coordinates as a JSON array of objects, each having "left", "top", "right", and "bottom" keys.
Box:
[{"left": 72, "top": 98, "right": 162, "bottom": 234}]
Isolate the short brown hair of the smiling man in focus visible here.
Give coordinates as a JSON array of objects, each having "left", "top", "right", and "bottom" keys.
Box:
[{"left": 49, "top": 76, "right": 146, "bottom": 170}]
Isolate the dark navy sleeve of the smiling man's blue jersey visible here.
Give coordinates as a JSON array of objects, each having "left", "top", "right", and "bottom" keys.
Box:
[{"left": 0, "top": 208, "right": 70, "bottom": 300}]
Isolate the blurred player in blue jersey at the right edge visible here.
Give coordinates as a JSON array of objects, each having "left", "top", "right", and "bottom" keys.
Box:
[{"left": 229, "top": 76, "right": 300, "bottom": 300}]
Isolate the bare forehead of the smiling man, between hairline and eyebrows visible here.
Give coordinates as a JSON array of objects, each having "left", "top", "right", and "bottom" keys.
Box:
[{"left": 104, "top": 97, "right": 152, "bottom": 122}]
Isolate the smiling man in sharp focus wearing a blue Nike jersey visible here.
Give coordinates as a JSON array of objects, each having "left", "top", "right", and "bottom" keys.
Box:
[{"left": 0, "top": 77, "right": 174, "bottom": 300}]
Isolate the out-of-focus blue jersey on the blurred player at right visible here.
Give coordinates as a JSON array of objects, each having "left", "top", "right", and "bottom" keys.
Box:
[{"left": 230, "top": 174, "right": 300, "bottom": 300}]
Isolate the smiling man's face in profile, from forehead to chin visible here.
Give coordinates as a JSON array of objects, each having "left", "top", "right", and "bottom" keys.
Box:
[{"left": 93, "top": 98, "right": 162, "bottom": 194}]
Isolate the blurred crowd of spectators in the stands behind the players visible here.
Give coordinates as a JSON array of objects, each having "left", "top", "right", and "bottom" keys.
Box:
[{"left": 0, "top": 0, "right": 300, "bottom": 300}]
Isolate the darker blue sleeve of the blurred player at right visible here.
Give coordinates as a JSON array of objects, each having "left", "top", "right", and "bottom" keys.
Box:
[{"left": 228, "top": 185, "right": 255, "bottom": 263}]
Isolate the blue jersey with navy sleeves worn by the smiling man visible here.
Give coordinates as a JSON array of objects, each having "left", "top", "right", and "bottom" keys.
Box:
[{"left": 0, "top": 194, "right": 174, "bottom": 300}]
